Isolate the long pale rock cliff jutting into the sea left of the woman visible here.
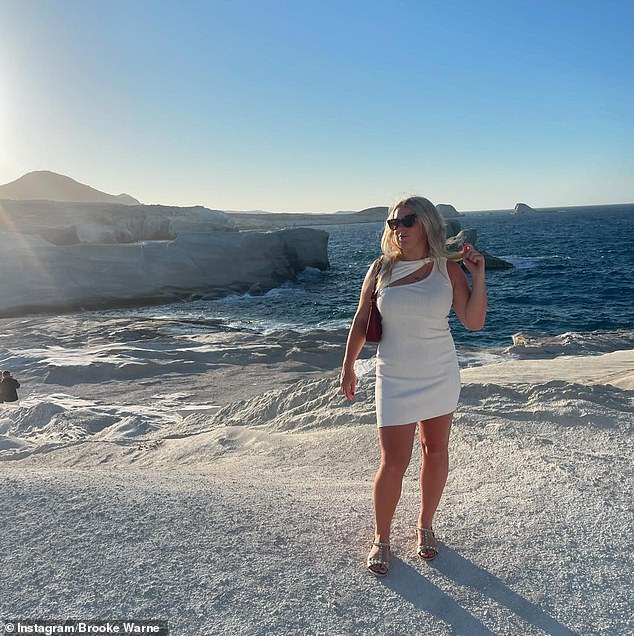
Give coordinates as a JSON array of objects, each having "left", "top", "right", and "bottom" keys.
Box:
[{"left": 0, "top": 228, "right": 328, "bottom": 316}]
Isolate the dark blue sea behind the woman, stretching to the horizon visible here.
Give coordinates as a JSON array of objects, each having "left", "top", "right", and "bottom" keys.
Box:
[{"left": 99, "top": 204, "right": 634, "bottom": 351}]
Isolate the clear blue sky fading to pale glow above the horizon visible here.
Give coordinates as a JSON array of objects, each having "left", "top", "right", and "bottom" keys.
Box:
[{"left": 0, "top": 0, "right": 634, "bottom": 211}]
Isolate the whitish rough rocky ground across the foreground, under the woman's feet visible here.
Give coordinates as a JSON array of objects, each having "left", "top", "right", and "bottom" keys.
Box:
[{"left": 0, "top": 314, "right": 634, "bottom": 636}]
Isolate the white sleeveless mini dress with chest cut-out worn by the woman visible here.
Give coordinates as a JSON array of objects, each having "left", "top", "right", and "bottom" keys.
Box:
[{"left": 375, "top": 258, "right": 460, "bottom": 427}]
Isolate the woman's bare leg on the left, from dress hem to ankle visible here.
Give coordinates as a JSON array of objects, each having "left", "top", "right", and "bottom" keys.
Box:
[{"left": 373, "top": 423, "right": 416, "bottom": 543}]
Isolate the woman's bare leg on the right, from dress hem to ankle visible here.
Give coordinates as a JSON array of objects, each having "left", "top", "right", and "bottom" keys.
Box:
[{"left": 418, "top": 413, "right": 453, "bottom": 528}]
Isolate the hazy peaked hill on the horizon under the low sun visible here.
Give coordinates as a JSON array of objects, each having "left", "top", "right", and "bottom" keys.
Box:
[{"left": 0, "top": 170, "right": 140, "bottom": 205}]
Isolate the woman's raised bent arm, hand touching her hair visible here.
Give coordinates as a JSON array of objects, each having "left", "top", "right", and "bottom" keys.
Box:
[{"left": 447, "top": 243, "right": 487, "bottom": 330}]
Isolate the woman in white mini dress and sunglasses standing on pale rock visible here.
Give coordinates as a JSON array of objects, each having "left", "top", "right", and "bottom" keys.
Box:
[{"left": 341, "top": 197, "right": 487, "bottom": 576}]
